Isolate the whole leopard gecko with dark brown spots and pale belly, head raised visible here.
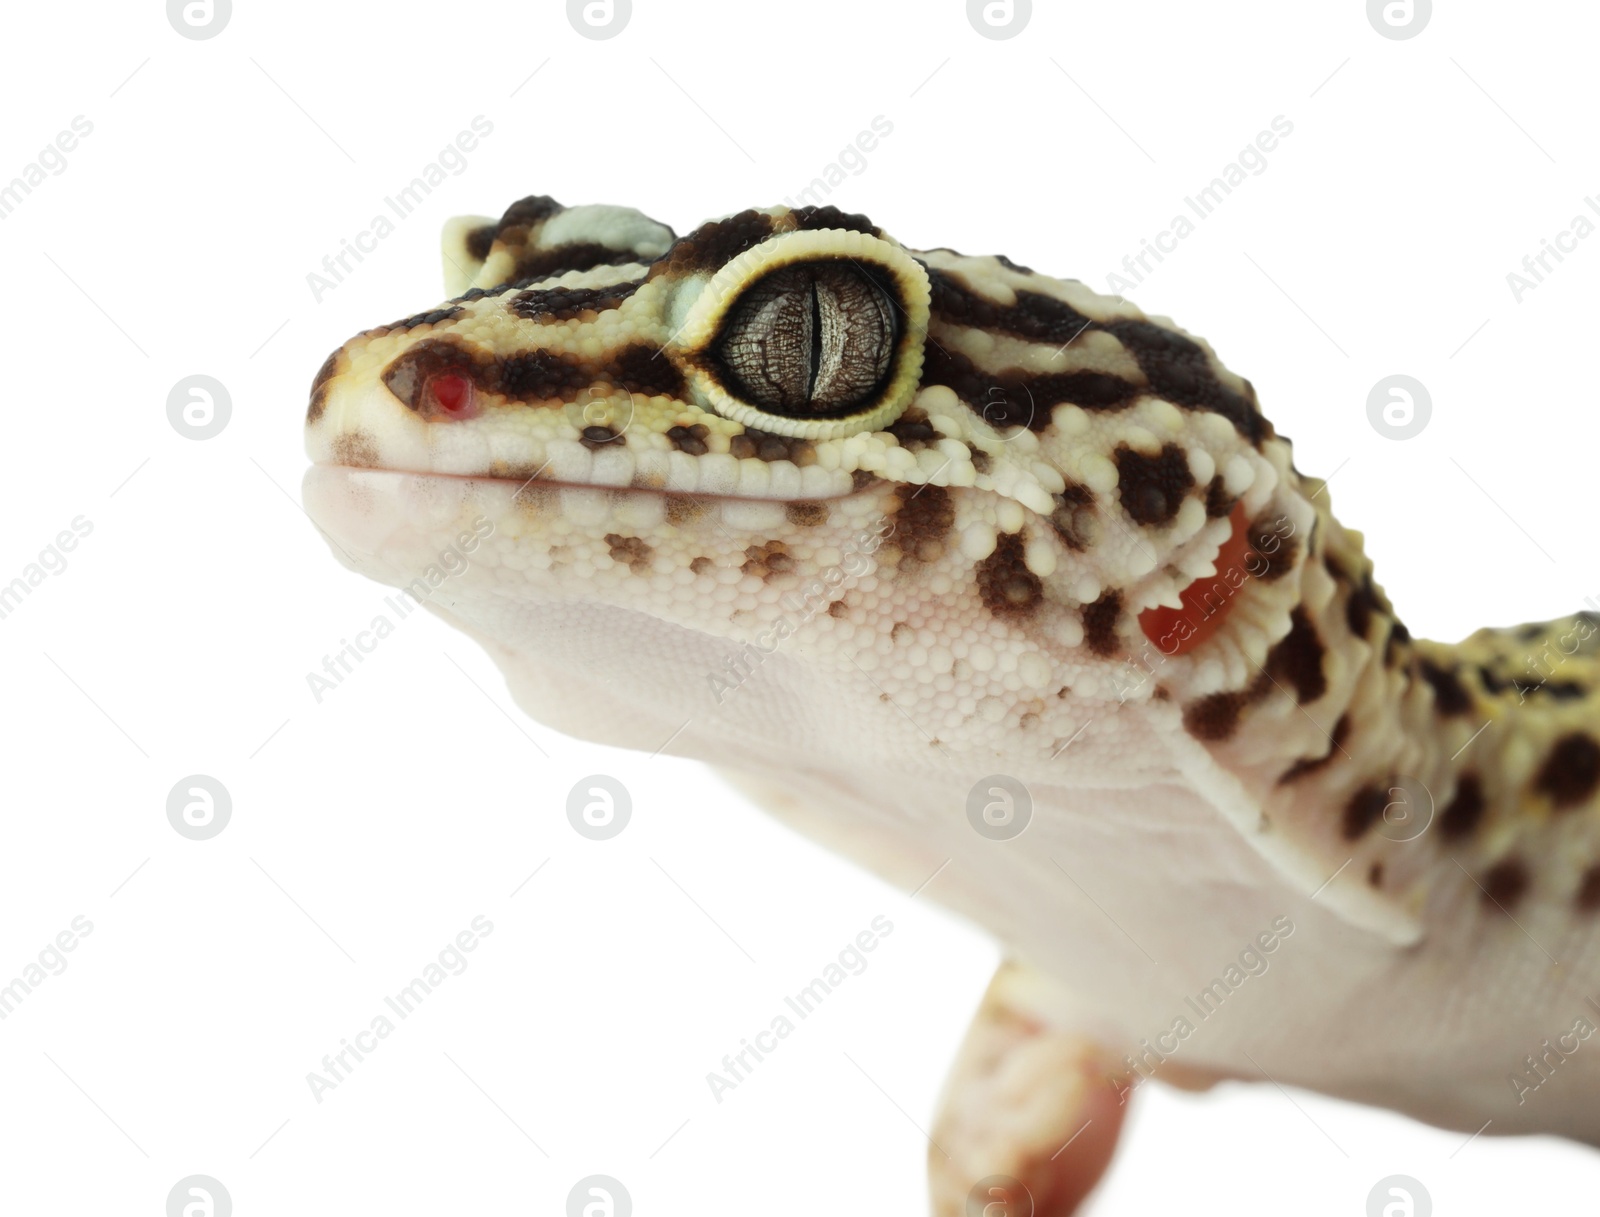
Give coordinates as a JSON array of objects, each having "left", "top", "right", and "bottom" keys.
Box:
[{"left": 304, "top": 195, "right": 1600, "bottom": 1217}]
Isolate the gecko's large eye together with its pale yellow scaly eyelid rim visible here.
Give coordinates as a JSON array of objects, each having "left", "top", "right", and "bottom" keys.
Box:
[{"left": 672, "top": 229, "right": 930, "bottom": 440}]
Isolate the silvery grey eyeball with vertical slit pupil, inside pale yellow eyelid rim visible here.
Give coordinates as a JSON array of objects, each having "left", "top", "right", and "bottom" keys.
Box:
[{"left": 712, "top": 262, "right": 898, "bottom": 419}]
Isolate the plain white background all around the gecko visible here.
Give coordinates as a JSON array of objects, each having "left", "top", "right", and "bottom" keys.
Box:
[{"left": 0, "top": 0, "right": 1600, "bottom": 1217}]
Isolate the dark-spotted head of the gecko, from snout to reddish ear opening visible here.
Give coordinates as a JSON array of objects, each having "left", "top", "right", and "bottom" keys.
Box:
[{"left": 306, "top": 197, "right": 1312, "bottom": 764}]
